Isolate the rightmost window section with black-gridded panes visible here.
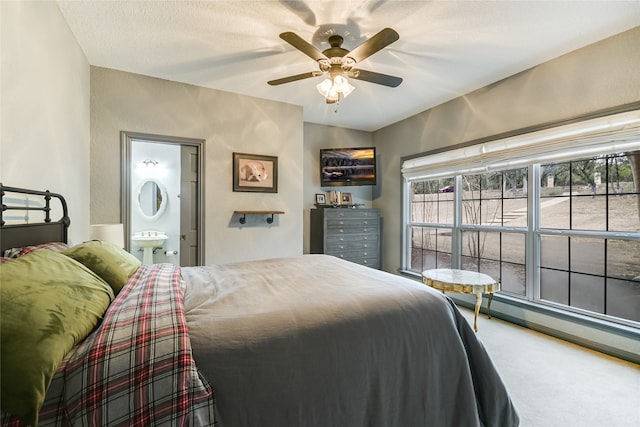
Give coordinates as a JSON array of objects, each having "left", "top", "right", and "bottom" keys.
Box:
[{"left": 538, "top": 154, "right": 640, "bottom": 322}]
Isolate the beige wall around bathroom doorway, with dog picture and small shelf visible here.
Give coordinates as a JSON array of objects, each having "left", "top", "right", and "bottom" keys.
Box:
[{"left": 90, "top": 67, "right": 303, "bottom": 264}]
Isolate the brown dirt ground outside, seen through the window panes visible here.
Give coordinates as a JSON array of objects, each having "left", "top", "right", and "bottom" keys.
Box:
[{"left": 412, "top": 189, "right": 640, "bottom": 280}]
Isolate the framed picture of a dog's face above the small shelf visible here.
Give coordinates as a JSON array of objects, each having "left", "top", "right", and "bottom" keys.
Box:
[{"left": 233, "top": 153, "right": 278, "bottom": 193}]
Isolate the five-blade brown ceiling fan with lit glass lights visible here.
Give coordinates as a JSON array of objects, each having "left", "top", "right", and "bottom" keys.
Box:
[{"left": 267, "top": 28, "right": 402, "bottom": 104}]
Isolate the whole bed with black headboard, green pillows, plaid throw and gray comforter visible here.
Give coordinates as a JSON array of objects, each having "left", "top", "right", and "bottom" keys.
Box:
[{"left": 0, "top": 187, "right": 519, "bottom": 427}]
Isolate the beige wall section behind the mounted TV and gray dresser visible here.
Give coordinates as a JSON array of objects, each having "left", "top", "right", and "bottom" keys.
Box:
[{"left": 303, "top": 123, "right": 374, "bottom": 253}]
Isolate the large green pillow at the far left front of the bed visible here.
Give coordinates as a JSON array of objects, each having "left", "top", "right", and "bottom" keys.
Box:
[{"left": 0, "top": 249, "right": 115, "bottom": 425}]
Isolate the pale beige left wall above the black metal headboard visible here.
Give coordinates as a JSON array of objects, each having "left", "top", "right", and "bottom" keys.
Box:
[{"left": 0, "top": 1, "right": 89, "bottom": 243}]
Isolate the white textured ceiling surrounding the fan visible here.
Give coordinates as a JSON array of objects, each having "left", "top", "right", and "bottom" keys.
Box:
[{"left": 58, "top": 0, "right": 640, "bottom": 131}]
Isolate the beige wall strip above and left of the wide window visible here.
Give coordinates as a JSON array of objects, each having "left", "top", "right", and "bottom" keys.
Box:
[{"left": 373, "top": 27, "right": 640, "bottom": 272}]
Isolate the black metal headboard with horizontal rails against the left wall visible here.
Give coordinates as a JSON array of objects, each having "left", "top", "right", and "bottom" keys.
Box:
[{"left": 0, "top": 184, "right": 71, "bottom": 255}]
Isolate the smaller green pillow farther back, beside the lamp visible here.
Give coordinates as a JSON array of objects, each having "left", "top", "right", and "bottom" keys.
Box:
[{"left": 62, "top": 240, "right": 141, "bottom": 294}]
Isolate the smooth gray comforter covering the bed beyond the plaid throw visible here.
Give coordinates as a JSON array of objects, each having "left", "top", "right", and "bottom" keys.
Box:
[{"left": 182, "top": 255, "right": 518, "bottom": 427}]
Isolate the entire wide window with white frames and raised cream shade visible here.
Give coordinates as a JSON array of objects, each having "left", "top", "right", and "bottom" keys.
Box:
[{"left": 403, "top": 112, "right": 640, "bottom": 328}]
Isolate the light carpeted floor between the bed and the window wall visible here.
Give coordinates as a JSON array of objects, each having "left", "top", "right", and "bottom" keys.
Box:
[{"left": 460, "top": 307, "right": 640, "bottom": 427}]
